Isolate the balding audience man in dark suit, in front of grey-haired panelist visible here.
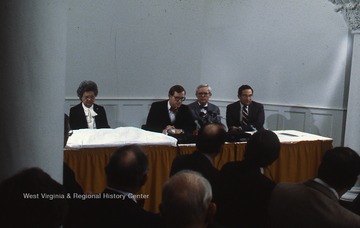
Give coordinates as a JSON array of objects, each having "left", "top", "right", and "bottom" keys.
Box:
[{"left": 170, "top": 123, "right": 226, "bottom": 194}]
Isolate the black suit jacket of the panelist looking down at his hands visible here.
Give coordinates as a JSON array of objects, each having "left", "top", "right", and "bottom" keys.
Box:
[{"left": 144, "top": 100, "right": 195, "bottom": 134}]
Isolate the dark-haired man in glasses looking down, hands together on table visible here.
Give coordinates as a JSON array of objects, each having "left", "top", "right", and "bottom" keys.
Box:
[{"left": 143, "top": 85, "right": 195, "bottom": 135}]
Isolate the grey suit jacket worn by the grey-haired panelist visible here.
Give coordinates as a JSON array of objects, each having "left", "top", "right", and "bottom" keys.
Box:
[{"left": 189, "top": 101, "right": 221, "bottom": 126}]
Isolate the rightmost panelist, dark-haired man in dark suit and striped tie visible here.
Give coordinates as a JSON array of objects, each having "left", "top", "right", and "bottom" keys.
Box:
[{"left": 226, "top": 85, "right": 265, "bottom": 131}]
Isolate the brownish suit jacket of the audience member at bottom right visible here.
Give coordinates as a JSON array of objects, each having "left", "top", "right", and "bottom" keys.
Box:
[{"left": 269, "top": 180, "right": 360, "bottom": 228}]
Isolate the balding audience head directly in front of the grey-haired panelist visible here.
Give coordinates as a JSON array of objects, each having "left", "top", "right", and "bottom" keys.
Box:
[{"left": 196, "top": 123, "right": 226, "bottom": 155}]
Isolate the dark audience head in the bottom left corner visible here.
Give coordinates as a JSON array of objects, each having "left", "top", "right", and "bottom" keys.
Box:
[{"left": 0, "top": 168, "right": 68, "bottom": 228}]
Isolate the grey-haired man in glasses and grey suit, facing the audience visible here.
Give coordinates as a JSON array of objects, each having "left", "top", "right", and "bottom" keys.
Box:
[{"left": 189, "top": 84, "right": 221, "bottom": 128}]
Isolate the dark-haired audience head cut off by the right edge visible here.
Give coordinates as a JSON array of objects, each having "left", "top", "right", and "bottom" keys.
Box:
[{"left": 318, "top": 147, "right": 360, "bottom": 193}]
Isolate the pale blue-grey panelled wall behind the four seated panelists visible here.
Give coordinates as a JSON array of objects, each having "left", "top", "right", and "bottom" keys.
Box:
[{"left": 66, "top": 0, "right": 351, "bottom": 145}]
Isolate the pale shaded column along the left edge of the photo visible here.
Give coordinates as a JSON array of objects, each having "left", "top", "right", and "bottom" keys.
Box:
[{"left": 0, "top": 0, "right": 67, "bottom": 182}]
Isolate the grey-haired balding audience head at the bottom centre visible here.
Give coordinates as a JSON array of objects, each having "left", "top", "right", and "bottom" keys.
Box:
[{"left": 160, "top": 170, "right": 216, "bottom": 228}]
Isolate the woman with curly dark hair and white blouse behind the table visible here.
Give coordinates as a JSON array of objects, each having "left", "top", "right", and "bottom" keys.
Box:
[{"left": 69, "top": 80, "right": 110, "bottom": 130}]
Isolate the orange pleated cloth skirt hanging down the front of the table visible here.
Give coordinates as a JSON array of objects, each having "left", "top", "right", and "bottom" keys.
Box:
[{"left": 64, "top": 131, "right": 332, "bottom": 212}]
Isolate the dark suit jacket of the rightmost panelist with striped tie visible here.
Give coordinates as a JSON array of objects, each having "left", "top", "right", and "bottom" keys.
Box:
[{"left": 226, "top": 101, "right": 265, "bottom": 131}]
